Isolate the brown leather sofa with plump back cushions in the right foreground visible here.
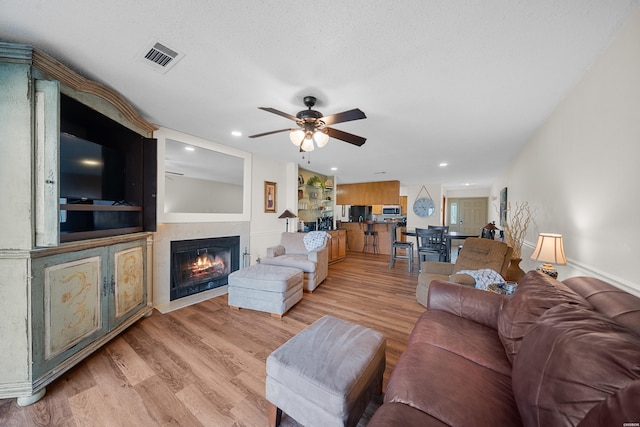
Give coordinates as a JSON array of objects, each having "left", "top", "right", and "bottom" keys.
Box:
[{"left": 368, "top": 271, "right": 640, "bottom": 427}]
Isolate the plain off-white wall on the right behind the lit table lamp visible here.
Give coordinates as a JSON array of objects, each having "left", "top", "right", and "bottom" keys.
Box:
[{"left": 490, "top": 12, "right": 640, "bottom": 295}]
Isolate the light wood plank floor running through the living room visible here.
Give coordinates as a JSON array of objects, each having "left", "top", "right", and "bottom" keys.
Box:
[{"left": 0, "top": 252, "right": 425, "bottom": 426}]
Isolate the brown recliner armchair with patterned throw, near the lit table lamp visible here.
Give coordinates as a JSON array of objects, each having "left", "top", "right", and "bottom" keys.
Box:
[{"left": 416, "top": 237, "right": 513, "bottom": 307}]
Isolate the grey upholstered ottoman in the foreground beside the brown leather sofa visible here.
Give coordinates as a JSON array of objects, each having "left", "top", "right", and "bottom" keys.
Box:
[{"left": 266, "top": 315, "right": 386, "bottom": 427}]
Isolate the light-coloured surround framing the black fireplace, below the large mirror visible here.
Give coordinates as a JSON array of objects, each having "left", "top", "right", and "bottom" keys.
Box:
[{"left": 153, "top": 222, "right": 249, "bottom": 313}]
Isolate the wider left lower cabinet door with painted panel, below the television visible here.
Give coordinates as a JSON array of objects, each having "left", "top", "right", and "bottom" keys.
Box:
[{"left": 31, "top": 248, "right": 107, "bottom": 378}]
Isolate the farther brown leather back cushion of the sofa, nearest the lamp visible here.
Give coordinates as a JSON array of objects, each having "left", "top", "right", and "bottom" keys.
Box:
[{"left": 498, "top": 271, "right": 592, "bottom": 364}]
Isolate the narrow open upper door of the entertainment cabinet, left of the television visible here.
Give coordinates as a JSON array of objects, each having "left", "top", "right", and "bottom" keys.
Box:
[{"left": 35, "top": 80, "right": 60, "bottom": 247}]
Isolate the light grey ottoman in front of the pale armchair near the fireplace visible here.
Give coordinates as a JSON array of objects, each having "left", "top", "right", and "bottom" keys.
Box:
[{"left": 228, "top": 264, "right": 304, "bottom": 317}]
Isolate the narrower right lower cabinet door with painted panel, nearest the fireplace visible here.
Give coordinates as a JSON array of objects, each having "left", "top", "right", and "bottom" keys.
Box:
[{"left": 109, "top": 239, "right": 147, "bottom": 330}]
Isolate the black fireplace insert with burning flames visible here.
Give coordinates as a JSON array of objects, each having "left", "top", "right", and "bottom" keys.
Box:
[{"left": 169, "top": 236, "right": 240, "bottom": 301}]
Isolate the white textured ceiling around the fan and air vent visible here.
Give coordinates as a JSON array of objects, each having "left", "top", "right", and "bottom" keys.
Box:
[{"left": 0, "top": 0, "right": 640, "bottom": 188}]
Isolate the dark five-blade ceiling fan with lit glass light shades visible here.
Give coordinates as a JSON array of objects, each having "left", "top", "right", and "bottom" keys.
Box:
[{"left": 249, "top": 96, "right": 367, "bottom": 151}]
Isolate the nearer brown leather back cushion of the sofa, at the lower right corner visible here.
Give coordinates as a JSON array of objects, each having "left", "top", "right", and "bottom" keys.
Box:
[{"left": 512, "top": 304, "right": 640, "bottom": 426}]
